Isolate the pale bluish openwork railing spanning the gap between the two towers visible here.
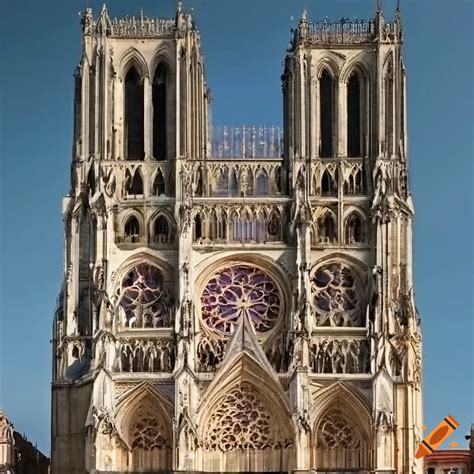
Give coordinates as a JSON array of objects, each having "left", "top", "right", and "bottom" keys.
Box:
[{"left": 211, "top": 126, "right": 283, "bottom": 158}]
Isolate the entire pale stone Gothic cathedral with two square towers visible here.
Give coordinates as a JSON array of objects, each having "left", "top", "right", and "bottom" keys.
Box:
[{"left": 51, "top": 0, "right": 423, "bottom": 474}]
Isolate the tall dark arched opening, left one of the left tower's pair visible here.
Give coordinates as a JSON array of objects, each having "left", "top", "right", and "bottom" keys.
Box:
[{"left": 125, "top": 66, "right": 145, "bottom": 160}]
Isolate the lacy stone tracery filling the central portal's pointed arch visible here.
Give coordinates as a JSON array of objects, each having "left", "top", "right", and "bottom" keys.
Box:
[{"left": 203, "top": 383, "right": 292, "bottom": 452}]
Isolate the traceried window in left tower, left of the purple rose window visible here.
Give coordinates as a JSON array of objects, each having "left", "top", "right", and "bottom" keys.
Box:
[{"left": 120, "top": 263, "right": 171, "bottom": 328}]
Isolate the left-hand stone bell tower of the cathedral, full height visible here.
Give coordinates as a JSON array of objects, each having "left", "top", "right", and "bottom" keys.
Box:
[{"left": 52, "top": 3, "right": 210, "bottom": 473}]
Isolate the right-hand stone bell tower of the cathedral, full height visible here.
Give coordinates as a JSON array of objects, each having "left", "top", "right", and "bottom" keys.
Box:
[{"left": 282, "top": 2, "right": 422, "bottom": 472}]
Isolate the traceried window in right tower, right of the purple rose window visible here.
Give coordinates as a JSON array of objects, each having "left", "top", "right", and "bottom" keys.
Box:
[{"left": 311, "top": 262, "right": 362, "bottom": 326}]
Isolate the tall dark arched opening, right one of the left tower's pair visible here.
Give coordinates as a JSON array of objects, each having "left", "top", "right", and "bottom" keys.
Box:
[{"left": 152, "top": 63, "right": 168, "bottom": 160}]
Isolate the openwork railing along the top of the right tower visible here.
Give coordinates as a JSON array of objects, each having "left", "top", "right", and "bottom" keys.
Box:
[{"left": 308, "top": 18, "right": 375, "bottom": 44}]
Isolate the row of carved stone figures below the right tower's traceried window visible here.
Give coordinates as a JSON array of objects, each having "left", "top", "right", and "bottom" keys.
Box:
[{"left": 310, "top": 339, "right": 370, "bottom": 374}]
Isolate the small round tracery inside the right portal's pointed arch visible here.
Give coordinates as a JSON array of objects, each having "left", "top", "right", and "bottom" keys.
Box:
[{"left": 319, "top": 410, "right": 359, "bottom": 449}]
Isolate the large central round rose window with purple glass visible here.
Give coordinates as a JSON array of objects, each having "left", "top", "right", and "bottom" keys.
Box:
[{"left": 201, "top": 265, "right": 282, "bottom": 336}]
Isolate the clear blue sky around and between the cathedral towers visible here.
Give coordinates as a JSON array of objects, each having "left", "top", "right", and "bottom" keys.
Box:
[{"left": 0, "top": 0, "right": 474, "bottom": 452}]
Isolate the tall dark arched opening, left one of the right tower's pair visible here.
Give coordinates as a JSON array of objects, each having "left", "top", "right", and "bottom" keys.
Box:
[{"left": 319, "top": 69, "right": 334, "bottom": 158}]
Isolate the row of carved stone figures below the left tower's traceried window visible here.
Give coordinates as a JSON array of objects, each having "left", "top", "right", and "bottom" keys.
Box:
[{"left": 120, "top": 339, "right": 175, "bottom": 372}]
